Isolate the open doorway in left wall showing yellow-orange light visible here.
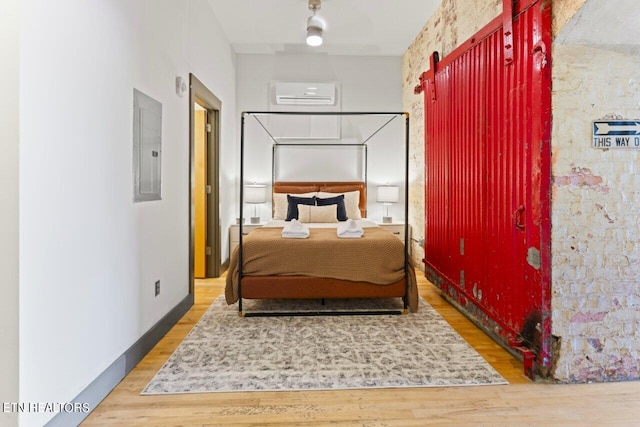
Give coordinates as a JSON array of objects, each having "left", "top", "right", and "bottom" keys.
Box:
[{"left": 189, "top": 74, "right": 222, "bottom": 293}]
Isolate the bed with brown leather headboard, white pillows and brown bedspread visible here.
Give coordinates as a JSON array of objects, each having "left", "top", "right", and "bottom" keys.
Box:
[{"left": 225, "top": 182, "right": 418, "bottom": 315}]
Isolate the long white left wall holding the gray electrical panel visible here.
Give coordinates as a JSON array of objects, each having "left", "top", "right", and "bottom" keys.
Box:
[{"left": 18, "top": 0, "right": 236, "bottom": 426}]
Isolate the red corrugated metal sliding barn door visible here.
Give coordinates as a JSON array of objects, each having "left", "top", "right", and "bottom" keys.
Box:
[{"left": 416, "top": 0, "right": 551, "bottom": 375}]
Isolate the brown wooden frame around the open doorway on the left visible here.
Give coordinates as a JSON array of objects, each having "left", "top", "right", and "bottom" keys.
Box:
[{"left": 189, "top": 73, "right": 222, "bottom": 293}]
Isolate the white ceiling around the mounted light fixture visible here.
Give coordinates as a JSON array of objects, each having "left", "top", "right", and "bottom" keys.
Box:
[{"left": 208, "top": 0, "right": 441, "bottom": 56}]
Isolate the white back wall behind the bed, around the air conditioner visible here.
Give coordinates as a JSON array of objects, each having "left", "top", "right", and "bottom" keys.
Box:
[{"left": 237, "top": 54, "right": 404, "bottom": 224}]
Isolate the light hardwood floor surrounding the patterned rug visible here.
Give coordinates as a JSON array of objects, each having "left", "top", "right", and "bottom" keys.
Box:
[{"left": 82, "top": 272, "right": 640, "bottom": 426}]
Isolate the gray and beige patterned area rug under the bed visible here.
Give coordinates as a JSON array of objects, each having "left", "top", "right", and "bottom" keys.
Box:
[{"left": 142, "top": 297, "right": 507, "bottom": 395}]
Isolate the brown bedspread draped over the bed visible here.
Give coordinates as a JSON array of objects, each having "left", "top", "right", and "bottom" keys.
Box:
[{"left": 225, "top": 227, "right": 418, "bottom": 312}]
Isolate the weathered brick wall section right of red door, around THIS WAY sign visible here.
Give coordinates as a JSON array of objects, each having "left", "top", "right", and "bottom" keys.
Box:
[{"left": 551, "top": 44, "right": 640, "bottom": 382}]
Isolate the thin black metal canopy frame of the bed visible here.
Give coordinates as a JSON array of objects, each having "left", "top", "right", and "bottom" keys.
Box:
[{"left": 238, "top": 111, "right": 410, "bottom": 317}]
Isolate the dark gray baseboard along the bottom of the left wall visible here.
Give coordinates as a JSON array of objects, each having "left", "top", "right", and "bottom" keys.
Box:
[{"left": 46, "top": 294, "right": 194, "bottom": 427}]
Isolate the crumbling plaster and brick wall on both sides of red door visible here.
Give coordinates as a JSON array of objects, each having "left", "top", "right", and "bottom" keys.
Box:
[{"left": 403, "top": 0, "right": 640, "bottom": 382}]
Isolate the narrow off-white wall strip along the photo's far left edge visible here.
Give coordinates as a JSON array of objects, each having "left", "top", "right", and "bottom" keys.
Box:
[{"left": 0, "top": 0, "right": 20, "bottom": 426}]
